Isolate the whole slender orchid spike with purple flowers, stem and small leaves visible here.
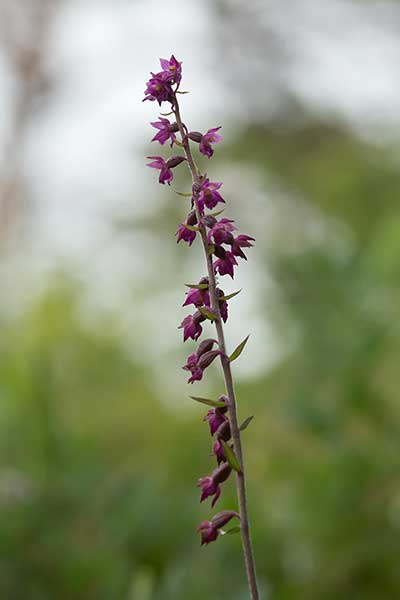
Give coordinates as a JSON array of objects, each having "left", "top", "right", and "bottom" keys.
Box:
[{"left": 144, "top": 56, "right": 259, "bottom": 600}]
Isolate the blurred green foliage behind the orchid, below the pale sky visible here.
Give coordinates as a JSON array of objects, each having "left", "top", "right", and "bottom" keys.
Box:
[{"left": 0, "top": 1, "right": 400, "bottom": 600}]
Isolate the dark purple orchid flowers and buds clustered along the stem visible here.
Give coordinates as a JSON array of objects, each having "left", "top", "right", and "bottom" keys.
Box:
[{"left": 144, "top": 55, "right": 254, "bottom": 545}]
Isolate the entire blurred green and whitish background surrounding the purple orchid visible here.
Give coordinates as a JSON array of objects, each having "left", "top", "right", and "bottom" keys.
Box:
[{"left": 0, "top": 0, "right": 400, "bottom": 600}]
